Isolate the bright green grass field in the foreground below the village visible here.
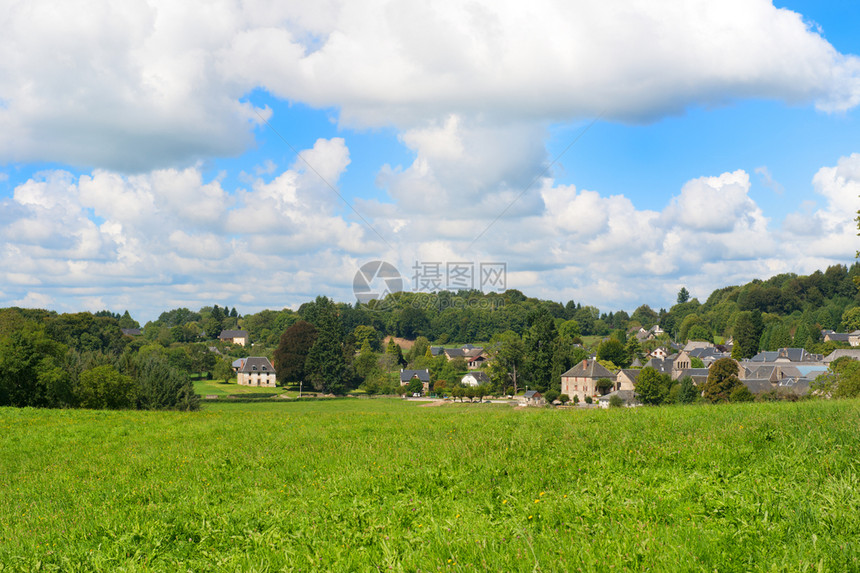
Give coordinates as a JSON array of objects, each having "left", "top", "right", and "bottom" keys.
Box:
[{"left": 0, "top": 399, "right": 860, "bottom": 572}]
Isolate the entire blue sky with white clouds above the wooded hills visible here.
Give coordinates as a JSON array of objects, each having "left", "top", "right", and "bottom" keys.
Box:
[{"left": 0, "top": 0, "right": 860, "bottom": 321}]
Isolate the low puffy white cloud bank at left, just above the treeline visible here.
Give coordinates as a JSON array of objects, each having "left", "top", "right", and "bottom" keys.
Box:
[{"left": 0, "top": 139, "right": 378, "bottom": 318}]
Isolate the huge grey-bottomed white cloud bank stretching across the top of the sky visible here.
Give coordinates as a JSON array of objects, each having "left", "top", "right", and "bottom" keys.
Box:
[{"left": 0, "top": 0, "right": 860, "bottom": 170}]
